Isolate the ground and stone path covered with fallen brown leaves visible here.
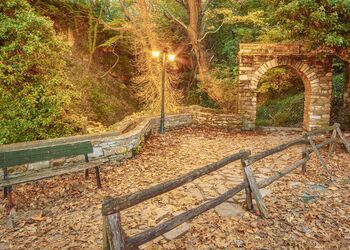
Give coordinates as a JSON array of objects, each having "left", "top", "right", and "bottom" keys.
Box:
[{"left": 0, "top": 128, "right": 350, "bottom": 249}]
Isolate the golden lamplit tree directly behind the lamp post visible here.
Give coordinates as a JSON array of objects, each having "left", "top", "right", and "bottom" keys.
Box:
[{"left": 106, "top": 0, "right": 181, "bottom": 113}]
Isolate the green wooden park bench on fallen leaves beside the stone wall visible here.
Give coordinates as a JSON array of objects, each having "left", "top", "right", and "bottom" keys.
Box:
[{"left": 0, "top": 141, "right": 101, "bottom": 206}]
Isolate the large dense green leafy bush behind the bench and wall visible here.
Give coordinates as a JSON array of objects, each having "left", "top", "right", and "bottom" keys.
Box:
[{"left": 0, "top": 0, "right": 81, "bottom": 144}]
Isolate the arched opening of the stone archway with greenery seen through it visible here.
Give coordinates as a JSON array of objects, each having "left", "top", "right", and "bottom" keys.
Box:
[{"left": 256, "top": 66, "right": 307, "bottom": 127}]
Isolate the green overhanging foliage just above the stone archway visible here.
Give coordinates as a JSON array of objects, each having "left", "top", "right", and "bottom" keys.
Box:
[{"left": 265, "top": 0, "right": 350, "bottom": 49}]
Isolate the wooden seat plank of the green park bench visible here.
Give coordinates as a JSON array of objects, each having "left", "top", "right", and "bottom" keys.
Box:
[{"left": 0, "top": 162, "right": 101, "bottom": 187}]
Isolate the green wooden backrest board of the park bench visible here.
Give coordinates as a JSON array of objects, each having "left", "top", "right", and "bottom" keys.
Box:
[{"left": 0, "top": 141, "right": 93, "bottom": 168}]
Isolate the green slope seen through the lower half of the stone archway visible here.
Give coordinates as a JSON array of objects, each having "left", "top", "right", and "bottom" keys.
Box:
[{"left": 256, "top": 93, "right": 304, "bottom": 127}]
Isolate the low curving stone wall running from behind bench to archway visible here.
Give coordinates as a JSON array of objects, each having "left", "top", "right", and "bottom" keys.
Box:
[{"left": 0, "top": 106, "right": 241, "bottom": 175}]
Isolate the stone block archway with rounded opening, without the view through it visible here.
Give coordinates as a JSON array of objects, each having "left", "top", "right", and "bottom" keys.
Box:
[{"left": 238, "top": 44, "right": 332, "bottom": 130}]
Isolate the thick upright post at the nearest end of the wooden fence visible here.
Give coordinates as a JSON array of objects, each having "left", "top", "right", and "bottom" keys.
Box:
[{"left": 106, "top": 213, "right": 126, "bottom": 250}]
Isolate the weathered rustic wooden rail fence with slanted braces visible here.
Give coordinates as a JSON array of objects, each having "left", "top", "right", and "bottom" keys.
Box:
[{"left": 102, "top": 124, "right": 350, "bottom": 250}]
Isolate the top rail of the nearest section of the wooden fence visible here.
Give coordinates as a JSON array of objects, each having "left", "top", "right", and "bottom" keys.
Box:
[{"left": 102, "top": 151, "right": 249, "bottom": 215}]
